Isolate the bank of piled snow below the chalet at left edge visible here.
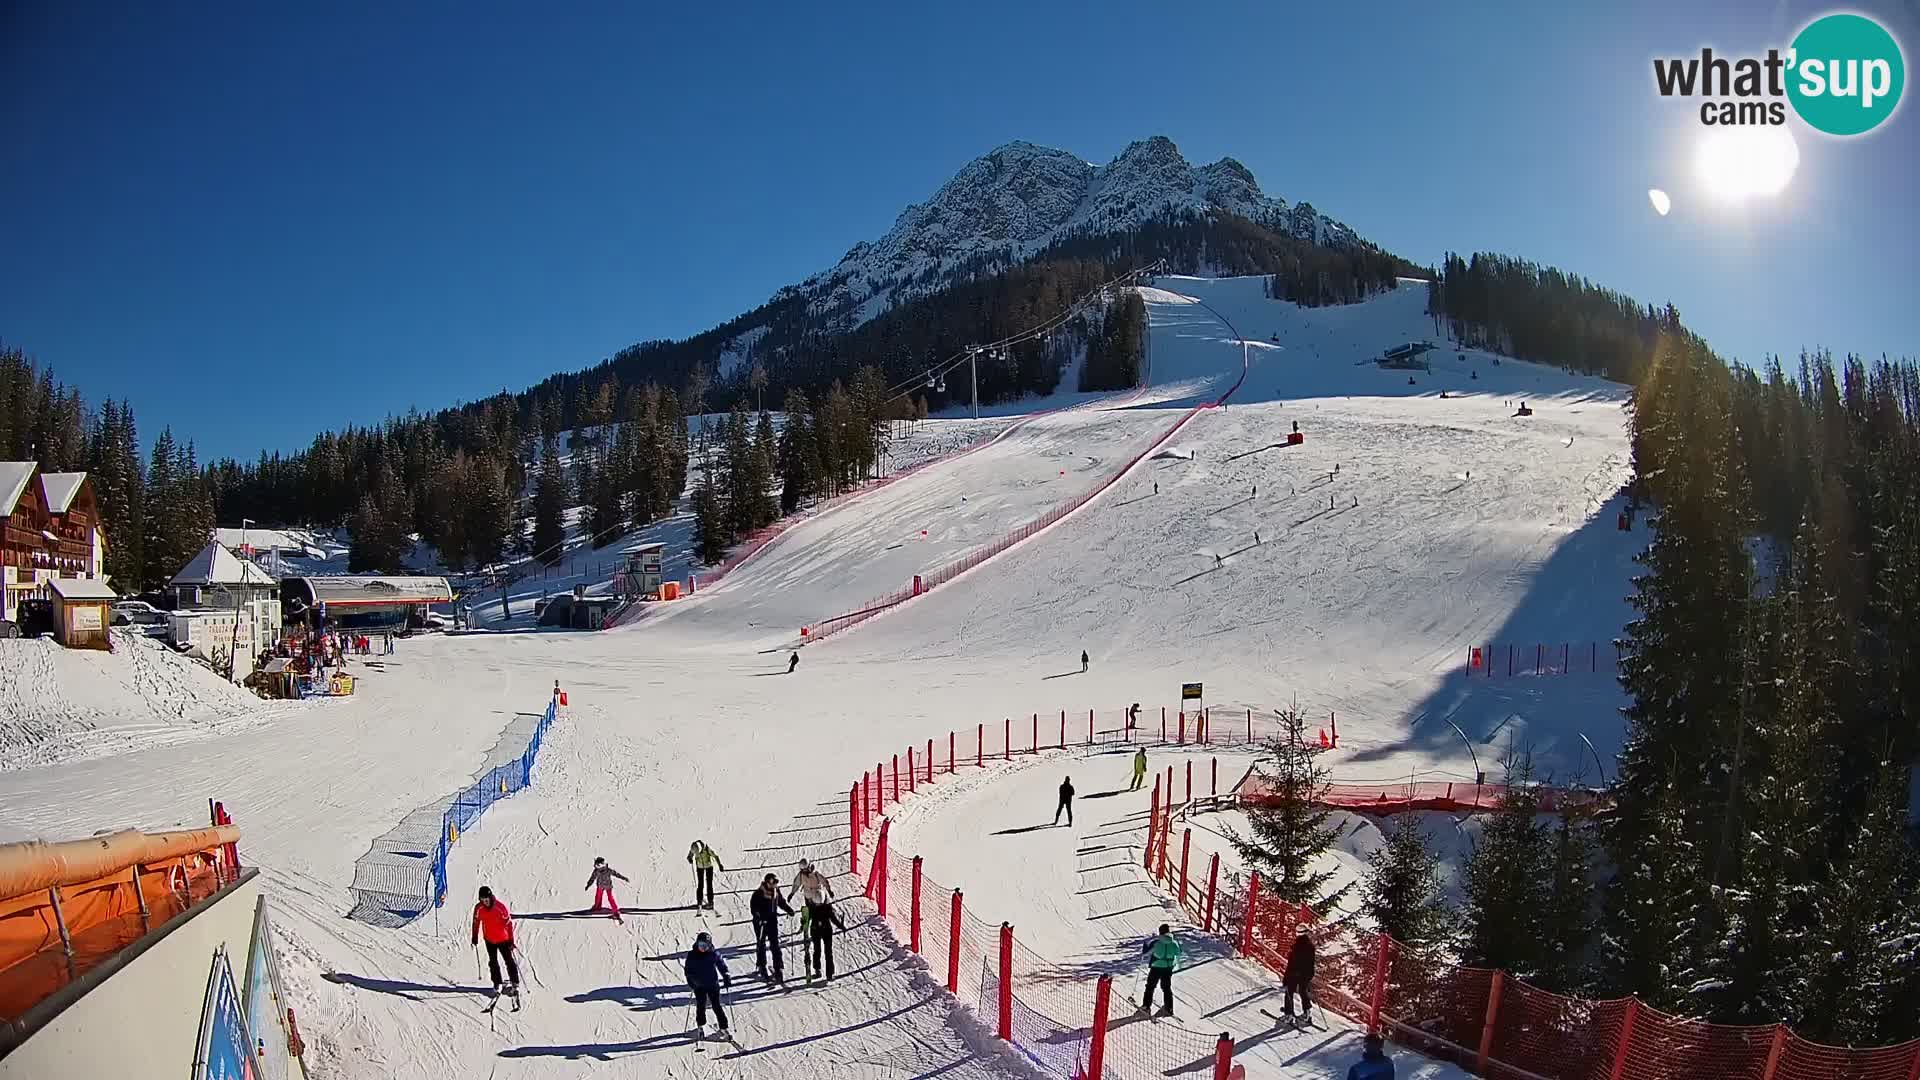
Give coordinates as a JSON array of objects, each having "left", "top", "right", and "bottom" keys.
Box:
[{"left": 0, "top": 630, "right": 276, "bottom": 771}]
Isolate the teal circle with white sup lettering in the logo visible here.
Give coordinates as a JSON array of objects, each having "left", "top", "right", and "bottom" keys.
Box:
[{"left": 1788, "top": 13, "right": 1907, "bottom": 135}]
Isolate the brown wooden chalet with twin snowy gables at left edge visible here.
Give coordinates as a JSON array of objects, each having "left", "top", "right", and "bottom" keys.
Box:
[{"left": 0, "top": 461, "right": 106, "bottom": 623}]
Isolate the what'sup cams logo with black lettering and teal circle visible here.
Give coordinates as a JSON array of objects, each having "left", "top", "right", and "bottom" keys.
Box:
[{"left": 1653, "top": 13, "right": 1907, "bottom": 136}]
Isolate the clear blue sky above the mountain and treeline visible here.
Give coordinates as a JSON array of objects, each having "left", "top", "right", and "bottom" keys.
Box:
[{"left": 0, "top": 0, "right": 1920, "bottom": 457}]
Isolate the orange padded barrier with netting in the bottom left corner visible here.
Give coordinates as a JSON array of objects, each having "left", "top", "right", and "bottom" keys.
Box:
[{"left": 0, "top": 826, "right": 240, "bottom": 1020}]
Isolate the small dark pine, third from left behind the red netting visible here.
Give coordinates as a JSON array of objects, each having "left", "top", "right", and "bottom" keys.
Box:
[{"left": 1461, "top": 757, "right": 1551, "bottom": 980}]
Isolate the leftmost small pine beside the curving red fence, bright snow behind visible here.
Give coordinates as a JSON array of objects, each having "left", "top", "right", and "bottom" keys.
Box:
[{"left": 1233, "top": 709, "right": 1352, "bottom": 915}]
